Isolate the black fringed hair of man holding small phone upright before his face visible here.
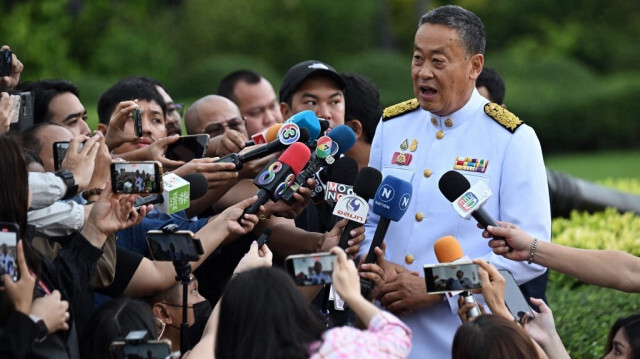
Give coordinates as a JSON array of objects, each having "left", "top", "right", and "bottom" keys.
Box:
[{"left": 98, "top": 77, "right": 167, "bottom": 125}]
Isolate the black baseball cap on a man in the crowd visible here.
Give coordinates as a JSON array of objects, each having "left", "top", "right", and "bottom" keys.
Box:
[{"left": 279, "top": 60, "right": 347, "bottom": 102}]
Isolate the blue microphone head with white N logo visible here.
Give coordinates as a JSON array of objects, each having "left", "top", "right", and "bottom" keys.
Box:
[{"left": 373, "top": 176, "right": 413, "bottom": 222}]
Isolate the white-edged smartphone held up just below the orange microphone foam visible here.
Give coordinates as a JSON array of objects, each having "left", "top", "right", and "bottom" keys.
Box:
[{"left": 424, "top": 263, "right": 482, "bottom": 294}]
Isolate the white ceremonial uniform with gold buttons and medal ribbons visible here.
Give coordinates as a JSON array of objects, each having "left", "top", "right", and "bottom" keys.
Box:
[{"left": 360, "top": 89, "right": 551, "bottom": 358}]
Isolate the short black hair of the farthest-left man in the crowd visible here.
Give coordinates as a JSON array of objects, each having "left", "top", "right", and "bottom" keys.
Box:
[{"left": 18, "top": 80, "right": 80, "bottom": 124}]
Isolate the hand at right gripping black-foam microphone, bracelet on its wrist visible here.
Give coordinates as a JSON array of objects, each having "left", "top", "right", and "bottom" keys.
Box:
[{"left": 482, "top": 222, "right": 533, "bottom": 261}]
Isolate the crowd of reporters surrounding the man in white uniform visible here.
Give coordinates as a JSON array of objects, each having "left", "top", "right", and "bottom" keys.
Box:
[{"left": 0, "top": 13, "right": 640, "bottom": 358}]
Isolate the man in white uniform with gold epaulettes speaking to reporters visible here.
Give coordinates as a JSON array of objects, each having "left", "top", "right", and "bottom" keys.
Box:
[{"left": 361, "top": 6, "right": 551, "bottom": 358}]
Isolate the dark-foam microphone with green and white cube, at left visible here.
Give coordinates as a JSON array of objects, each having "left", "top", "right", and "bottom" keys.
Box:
[{"left": 134, "top": 173, "right": 209, "bottom": 214}]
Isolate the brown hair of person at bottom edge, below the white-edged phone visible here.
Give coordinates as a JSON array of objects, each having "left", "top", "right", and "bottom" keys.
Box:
[{"left": 451, "top": 315, "right": 538, "bottom": 359}]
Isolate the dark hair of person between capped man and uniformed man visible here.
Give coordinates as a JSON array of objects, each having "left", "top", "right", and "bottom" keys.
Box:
[{"left": 340, "top": 72, "right": 382, "bottom": 143}]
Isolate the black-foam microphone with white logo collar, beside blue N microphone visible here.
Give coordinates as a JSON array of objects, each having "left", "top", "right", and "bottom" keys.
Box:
[{"left": 333, "top": 167, "right": 382, "bottom": 249}]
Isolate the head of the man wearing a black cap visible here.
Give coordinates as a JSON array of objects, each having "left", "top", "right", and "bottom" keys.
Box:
[{"left": 280, "top": 60, "right": 345, "bottom": 132}]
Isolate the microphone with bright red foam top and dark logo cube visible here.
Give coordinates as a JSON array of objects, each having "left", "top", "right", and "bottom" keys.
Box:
[{"left": 238, "top": 142, "right": 311, "bottom": 221}]
